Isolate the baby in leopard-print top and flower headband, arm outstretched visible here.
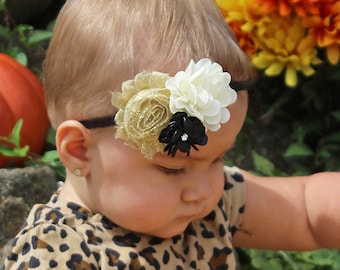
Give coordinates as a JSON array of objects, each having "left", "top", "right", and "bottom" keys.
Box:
[{"left": 4, "top": 0, "right": 340, "bottom": 269}]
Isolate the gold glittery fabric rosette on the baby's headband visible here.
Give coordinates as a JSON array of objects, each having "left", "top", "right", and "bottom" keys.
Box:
[{"left": 112, "top": 71, "right": 172, "bottom": 159}]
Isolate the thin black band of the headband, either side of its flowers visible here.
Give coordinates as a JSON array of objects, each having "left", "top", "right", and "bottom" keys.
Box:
[{"left": 79, "top": 80, "right": 251, "bottom": 129}]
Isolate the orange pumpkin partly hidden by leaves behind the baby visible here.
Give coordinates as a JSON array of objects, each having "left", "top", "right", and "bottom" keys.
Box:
[{"left": 0, "top": 53, "right": 50, "bottom": 168}]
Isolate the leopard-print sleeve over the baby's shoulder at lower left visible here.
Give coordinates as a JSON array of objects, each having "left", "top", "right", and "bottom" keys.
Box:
[{"left": 3, "top": 224, "right": 99, "bottom": 270}]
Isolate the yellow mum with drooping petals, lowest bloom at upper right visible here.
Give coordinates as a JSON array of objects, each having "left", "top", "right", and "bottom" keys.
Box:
[{"left": 252, "top": 14, "right": 321, "bottom": 87}]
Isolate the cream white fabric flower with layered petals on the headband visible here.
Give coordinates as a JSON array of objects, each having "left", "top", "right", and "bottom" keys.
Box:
[{"left": 165, "top": 58, "right": 237, "bottom": 131}]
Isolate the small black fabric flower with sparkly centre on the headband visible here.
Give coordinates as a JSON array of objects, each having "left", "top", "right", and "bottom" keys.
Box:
[{"left": 158, "top": 112, "right": 208, "bottom": 157}]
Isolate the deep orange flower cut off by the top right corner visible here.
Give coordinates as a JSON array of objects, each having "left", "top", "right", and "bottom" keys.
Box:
[{"left": 303, "top": 0, "right": 340, "bottom": 64}]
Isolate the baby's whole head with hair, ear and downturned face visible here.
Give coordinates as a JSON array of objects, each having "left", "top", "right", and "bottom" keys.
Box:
[{"left": 43, "top": 0, "right": 250, "bottom": 237}]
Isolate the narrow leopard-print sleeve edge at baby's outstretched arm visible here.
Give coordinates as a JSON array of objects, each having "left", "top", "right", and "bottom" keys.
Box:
[{"left": 224, "top": 166, "right": 245, "bottom": 234}]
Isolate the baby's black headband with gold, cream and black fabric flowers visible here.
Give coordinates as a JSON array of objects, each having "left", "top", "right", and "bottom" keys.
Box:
[{"left": 80, "top": 58, "right": 248, "bottom": 159}]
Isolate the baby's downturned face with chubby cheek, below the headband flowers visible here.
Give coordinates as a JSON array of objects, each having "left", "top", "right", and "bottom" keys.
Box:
[{"left": 83, "top": 91, "right": 247, "bottom": 238}]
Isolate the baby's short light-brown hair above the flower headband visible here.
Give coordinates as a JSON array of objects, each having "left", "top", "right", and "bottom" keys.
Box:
[{"left": 43, "top": 0, "right": 250, "bottom": 127}]
